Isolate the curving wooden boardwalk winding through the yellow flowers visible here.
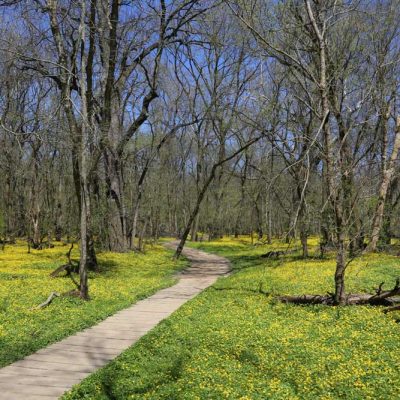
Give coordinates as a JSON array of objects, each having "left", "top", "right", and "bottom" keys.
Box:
[{"left": 0, "top": 243, "right": 230, "bottom": 400}]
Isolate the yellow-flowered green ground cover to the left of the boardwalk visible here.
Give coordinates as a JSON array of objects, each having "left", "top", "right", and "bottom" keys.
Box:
[{"left": 0, "top": 242, "right": 187, "bottom": 367}]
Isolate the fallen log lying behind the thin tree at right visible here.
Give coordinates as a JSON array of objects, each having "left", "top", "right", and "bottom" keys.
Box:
[{"left": 278, "top": 278, "right": 400, "bottom": 313}]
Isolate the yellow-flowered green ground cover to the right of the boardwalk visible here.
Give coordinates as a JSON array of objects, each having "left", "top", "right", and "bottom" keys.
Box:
[{"left": 63, "top": 239, "right": 400, "bottom": 400}]
